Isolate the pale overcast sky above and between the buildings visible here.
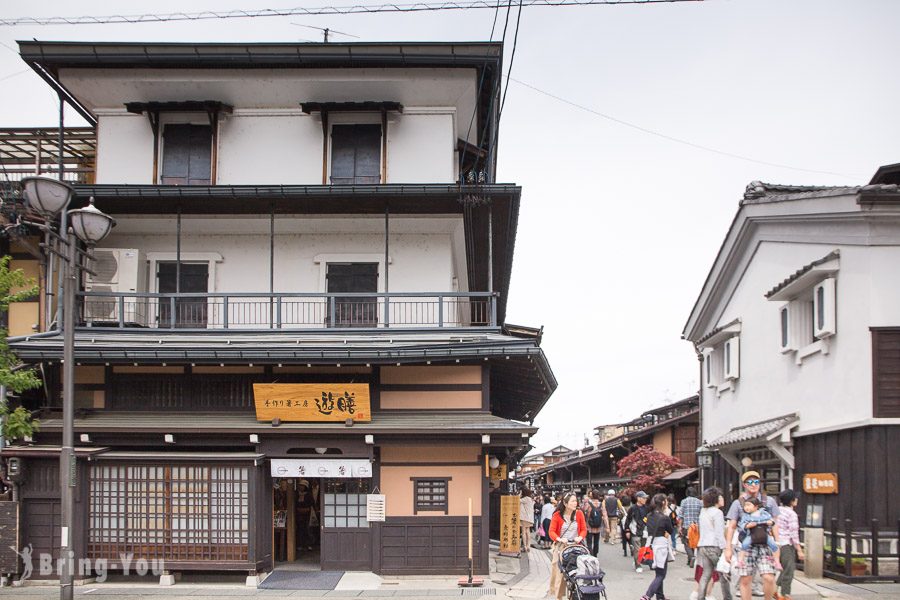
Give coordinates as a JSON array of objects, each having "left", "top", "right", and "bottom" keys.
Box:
[{"left": 0, "top": 0, "right": 900, "bottom": 450}]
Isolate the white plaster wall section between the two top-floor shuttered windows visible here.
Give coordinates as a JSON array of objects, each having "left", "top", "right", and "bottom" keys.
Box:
[{"left": 217, "top": 110, "right": 322, "bottom": 185}]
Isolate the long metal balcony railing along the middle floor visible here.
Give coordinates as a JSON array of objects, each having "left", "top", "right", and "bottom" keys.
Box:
[{"left": 78, "top": 292, "right": 497, "bottom": 331}]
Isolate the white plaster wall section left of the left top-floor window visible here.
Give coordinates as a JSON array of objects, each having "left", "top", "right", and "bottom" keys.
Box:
[{"left": 96, "top": 111, "right": 153, "bottom": 184}]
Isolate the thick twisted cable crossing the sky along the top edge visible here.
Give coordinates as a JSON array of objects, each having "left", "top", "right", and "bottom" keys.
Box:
[{"left": 0, "top": 0, "right": 705, "bottom": 27}]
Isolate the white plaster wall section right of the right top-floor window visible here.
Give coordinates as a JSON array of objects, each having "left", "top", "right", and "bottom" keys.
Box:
[{"left": 388, "top": 111, "right": 456, "bottom": 183}]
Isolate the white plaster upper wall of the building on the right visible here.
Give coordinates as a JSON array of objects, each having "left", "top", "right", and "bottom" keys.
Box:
[{"left": 703, "top": 242, "right": 900, "bottom": 440}]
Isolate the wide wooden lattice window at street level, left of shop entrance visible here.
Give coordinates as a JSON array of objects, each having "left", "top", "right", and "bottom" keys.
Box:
[{"left": 88, "top": 464, "right": 250, "bottom": 561}]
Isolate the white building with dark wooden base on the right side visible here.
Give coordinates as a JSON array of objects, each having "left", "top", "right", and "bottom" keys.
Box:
[{"left": 683, "top": 165, "right": 900, "bottom": 527}]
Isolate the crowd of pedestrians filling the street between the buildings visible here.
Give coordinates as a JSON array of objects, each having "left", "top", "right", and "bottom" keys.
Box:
[{"left": 520, "top": 471, "right": 803, "bottom": 600}]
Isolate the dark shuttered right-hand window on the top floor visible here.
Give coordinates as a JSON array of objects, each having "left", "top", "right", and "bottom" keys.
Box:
[{"left": 331, "top": 125, "right": 381, "bottom": 184}]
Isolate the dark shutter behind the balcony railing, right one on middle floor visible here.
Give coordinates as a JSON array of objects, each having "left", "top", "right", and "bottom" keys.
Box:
[{"left": 325, "top": 263, "right": 378, "bottom": 327}]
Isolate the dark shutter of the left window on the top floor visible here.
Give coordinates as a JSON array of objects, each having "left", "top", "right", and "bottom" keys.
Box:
[{"left": 160, "top": 124, "right": 212, "bottom": 185}]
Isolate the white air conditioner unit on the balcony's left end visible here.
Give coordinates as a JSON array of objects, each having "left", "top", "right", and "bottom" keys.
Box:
[{"left": 84, "top": 248, "right": 148, "bottom": 326}]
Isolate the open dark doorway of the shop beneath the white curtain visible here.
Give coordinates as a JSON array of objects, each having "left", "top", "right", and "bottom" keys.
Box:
[{"left": 272, "top": 477, "right": 324, "bottom": 571}]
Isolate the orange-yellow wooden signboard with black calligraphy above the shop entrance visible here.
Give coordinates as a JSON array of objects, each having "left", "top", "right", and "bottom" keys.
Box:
[{"left": 253, "top": 383, "right": 372, "bottom": 423}]
